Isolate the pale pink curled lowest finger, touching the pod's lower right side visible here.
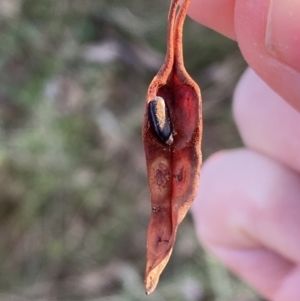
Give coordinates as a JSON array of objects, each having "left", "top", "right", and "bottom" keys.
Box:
[{"left": 192, "top": 150, "right": 300, "bottom": 301}]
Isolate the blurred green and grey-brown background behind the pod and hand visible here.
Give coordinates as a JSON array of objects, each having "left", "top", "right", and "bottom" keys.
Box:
[{"left": 0, "top": 0, "right": 261, "bottom": 301}]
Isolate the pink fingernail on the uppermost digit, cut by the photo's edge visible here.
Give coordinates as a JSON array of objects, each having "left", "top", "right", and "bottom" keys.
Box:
[{"left": 265, "top": 0, "right": 300, "bottom": 71}]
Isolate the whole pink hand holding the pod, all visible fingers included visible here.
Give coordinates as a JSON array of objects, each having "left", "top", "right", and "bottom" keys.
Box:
[{"left": 189, "top": 0, "right": 300, "bottom": 301}]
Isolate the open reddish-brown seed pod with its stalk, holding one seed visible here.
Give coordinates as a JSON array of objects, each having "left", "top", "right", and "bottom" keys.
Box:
[{"left": 143, "top": 0, "right": 202, "bottom": 294}]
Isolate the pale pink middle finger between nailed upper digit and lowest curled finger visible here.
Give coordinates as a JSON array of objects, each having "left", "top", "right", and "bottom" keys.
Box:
[{"left": 233, "top": 69, "right": 300, "bottom": 172}]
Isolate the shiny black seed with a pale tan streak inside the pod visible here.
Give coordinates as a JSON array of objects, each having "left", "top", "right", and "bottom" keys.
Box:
[{"left": 149, "top": 96, "right": 173, "bottom": 145}]
